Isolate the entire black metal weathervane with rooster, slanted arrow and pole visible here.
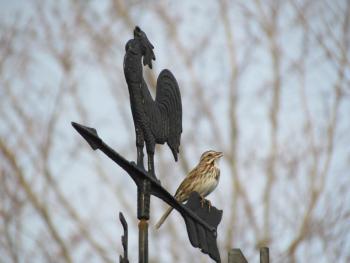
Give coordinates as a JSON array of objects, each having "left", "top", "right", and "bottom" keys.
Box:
[{"left": 72, "top": 27, "right": 222, "bottom": 263}]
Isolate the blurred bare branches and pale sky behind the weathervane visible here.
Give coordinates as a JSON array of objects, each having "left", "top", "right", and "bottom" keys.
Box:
[{"left": 0, "top": 0, "right": 350, "bottom": 262}]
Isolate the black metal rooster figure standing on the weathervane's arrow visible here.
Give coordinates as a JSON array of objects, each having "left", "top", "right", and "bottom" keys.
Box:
[{"left": 124, "top": 27, "right": 182, "bottom": 179}]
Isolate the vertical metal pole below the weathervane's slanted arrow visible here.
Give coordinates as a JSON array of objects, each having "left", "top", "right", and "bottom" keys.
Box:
[{"left": 137, "top": 180, "right": 151, "bottom": 263}]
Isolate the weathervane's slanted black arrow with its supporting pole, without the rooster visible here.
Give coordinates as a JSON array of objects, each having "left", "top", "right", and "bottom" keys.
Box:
[{"left": 72, "top": 122, "right": 222, "bottom": 262}]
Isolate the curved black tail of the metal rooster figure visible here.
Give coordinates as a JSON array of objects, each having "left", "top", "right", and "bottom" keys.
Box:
[{"left": 155, "top": 69, "right": 182, "bottom": 161}]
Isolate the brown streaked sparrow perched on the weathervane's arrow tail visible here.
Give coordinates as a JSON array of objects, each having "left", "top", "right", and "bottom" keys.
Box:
[{"left": 155, "top": 150, "right": 223, "bottom": 229}]
